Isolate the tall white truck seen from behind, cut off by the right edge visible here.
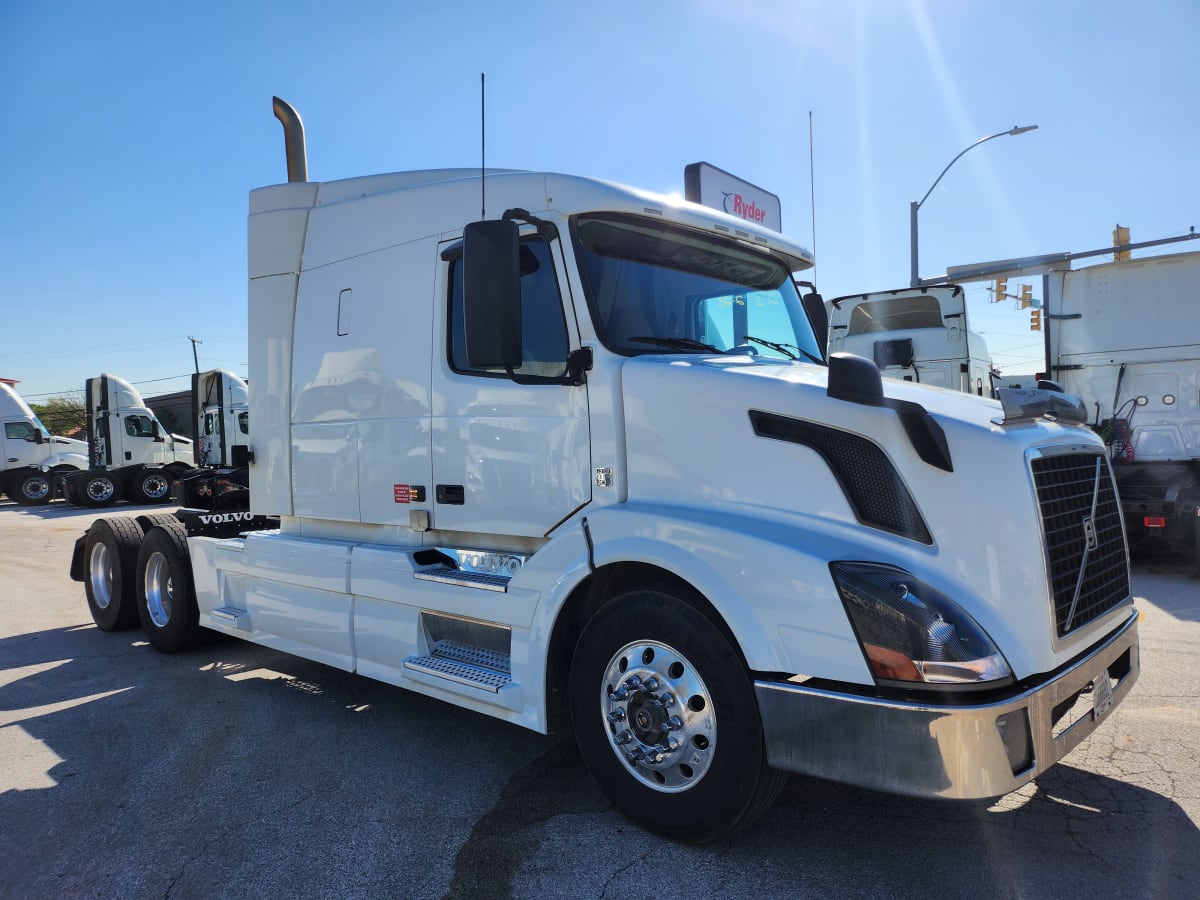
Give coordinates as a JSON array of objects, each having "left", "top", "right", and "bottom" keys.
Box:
[{"left": 1043, "top": 252, "right": 1200, "bottom": 563}]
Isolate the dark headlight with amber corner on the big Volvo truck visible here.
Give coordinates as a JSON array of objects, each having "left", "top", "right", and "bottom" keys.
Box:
[{"left": 829, "top": 563, "right": 1012, "bottom": 686}]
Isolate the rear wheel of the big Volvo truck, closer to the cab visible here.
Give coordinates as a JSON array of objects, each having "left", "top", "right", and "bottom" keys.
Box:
[{"left": 137, "top": 522, "right": 203, "bottom": 653}]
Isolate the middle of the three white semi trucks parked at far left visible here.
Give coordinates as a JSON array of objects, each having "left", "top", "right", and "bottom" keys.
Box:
[{"left": 61, "top": 374, "right": 194, "bottom": 508}]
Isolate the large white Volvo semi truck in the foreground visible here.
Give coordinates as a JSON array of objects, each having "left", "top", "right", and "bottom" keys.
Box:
[{"left": 71, "top": 101, "right": 1139, "bottom": 841}]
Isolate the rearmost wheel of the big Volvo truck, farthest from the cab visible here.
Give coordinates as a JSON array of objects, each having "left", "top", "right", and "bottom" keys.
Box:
[{"left": 83, "top": 518, "right": 142, "bottom": 631}]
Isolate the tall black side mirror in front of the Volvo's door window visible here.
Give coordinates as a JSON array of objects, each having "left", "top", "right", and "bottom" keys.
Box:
[{"left": 462, "top": 220, "right": 522, "bottom": 368}]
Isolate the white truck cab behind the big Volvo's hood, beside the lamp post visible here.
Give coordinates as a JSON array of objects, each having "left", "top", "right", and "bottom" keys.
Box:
[{"left": 828, "top": 284, "right": 994, "bottom": 397}]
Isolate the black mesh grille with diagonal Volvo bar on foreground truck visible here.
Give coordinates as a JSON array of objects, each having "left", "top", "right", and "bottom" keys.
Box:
[{"left": 1032, "top": 454, "right": 1129, "bottom": 637}]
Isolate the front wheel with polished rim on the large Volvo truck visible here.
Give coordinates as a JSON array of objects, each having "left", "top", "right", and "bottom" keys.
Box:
[{"left": 570, "top": 589, "right": 787, "bottom": 844}]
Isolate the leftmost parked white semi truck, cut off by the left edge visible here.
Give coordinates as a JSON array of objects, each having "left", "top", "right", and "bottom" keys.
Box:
[{"left": 0, "top": 382, "right": 88, "bottom": 506}]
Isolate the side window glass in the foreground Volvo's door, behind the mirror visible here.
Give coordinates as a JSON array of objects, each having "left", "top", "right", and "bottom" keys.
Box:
[{"left": 450, "top": 240, "right": 568, "bottom": 379}]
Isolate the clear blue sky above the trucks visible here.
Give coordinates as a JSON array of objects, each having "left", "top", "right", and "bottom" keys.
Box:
[{"left": 0, "top": 0, "right": 1200, "bottom": 402}]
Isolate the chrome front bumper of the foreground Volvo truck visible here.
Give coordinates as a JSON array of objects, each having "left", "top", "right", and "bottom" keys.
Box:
[{"left": 755, "top": 610, "right": 1140, "bottom": 799}]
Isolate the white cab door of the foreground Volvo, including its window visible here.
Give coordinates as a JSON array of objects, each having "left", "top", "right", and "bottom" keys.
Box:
[{"left": 430, "top": 234, "right": 592, "bottom": 538}]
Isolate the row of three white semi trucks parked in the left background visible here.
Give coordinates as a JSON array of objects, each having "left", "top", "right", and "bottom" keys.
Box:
[{"left": 0, "top": 370, "right": 250, "bottom": 508}]
